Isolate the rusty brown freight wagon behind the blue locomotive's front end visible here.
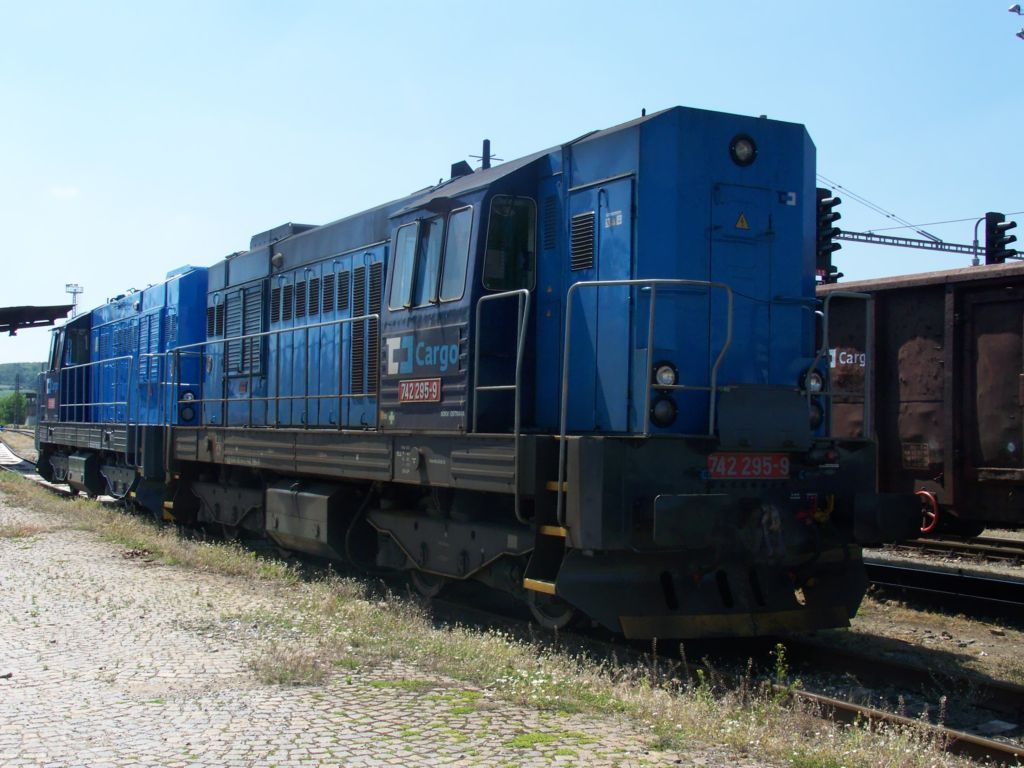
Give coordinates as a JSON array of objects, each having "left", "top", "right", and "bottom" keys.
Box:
[{"left": 818, "top": 263, "right": 1024, "bottom": 536}]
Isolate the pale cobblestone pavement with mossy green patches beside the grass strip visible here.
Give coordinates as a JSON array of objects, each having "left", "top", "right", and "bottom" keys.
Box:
[{"left": 0, "top": 498, "right": 754, "bottom": 768}]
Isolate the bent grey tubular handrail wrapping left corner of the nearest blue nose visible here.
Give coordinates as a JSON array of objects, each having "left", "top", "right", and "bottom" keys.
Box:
[{"left": 555, "top": 278, "right": 733, "bottom": 525}]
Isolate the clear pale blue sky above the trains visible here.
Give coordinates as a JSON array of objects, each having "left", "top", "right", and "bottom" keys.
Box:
[{"left": 0, "top": 0, "right": 1024, "bottom": 361}]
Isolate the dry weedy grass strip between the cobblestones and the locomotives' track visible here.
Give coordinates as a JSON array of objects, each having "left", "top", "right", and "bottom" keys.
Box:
[{"left": 0, "top": 477, "right": 971, "bottom": 768}]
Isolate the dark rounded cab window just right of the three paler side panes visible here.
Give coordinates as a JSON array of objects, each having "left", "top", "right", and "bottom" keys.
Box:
[{"left": 483, "top": 195, "right": 537, "bottom": 291}]
